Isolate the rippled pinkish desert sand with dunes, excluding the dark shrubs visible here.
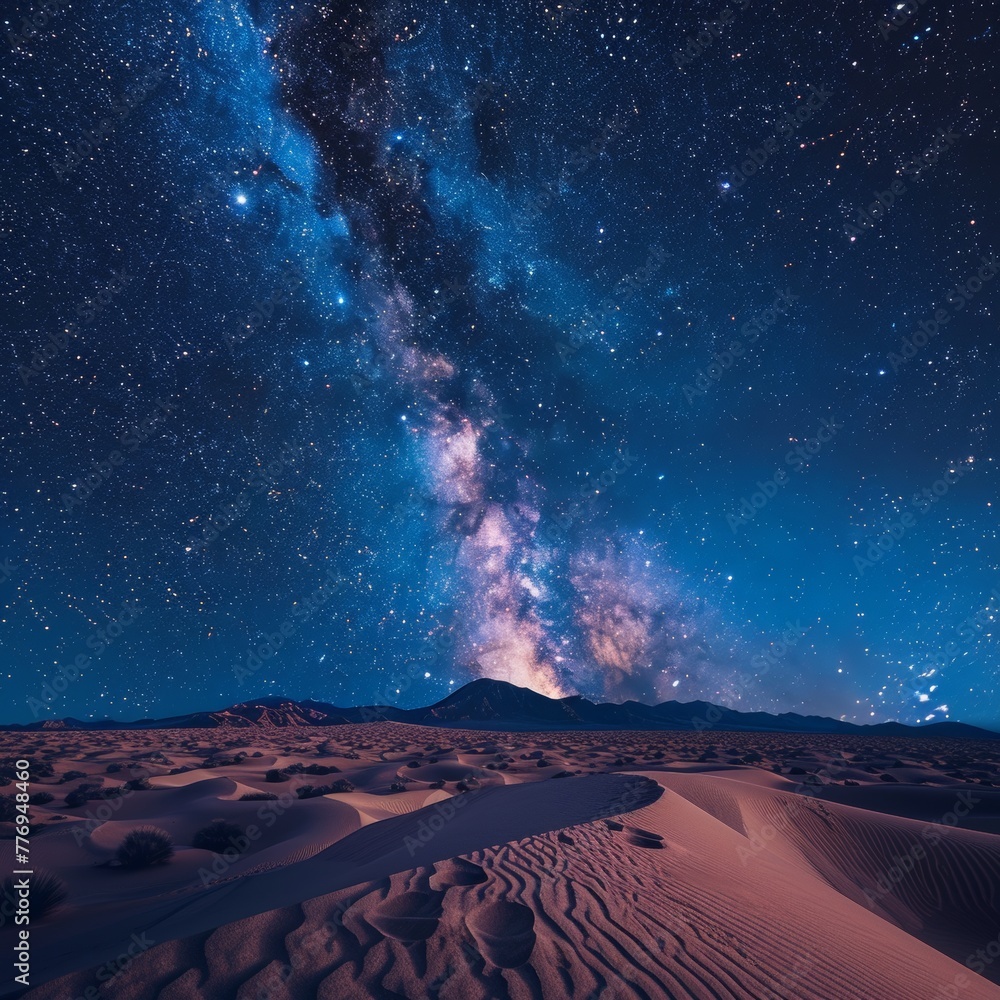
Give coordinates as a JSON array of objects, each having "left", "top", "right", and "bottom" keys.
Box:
[{"left": 0, "top": 723, "right": 1000, "bottom": 1000}]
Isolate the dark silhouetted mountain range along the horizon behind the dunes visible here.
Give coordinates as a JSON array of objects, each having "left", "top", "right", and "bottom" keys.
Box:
[{"left": 0, "top": 678, "right": 1000, "bottom": 739}]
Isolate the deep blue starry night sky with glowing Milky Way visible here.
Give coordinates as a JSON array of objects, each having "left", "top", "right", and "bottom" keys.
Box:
[{"left": 0, "top": 0, "right": 1000, "bottom": 725}]
